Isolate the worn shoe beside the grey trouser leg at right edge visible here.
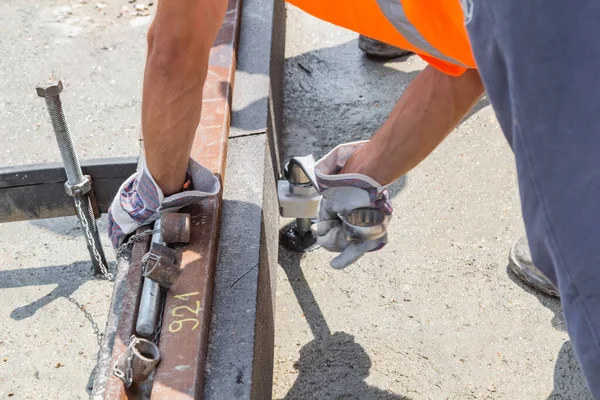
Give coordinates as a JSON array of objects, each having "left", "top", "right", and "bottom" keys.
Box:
[{"left": 509, "top": 236, "right": 559, "bottom": 297}]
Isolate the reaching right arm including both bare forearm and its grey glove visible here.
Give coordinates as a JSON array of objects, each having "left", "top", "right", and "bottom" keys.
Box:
[{"left": 313, "top": 67, "right": 484, "bottom": 268}]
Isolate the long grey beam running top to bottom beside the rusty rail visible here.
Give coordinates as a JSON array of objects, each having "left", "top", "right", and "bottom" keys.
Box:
[{"left": 203, "top": 0, "right": 285, "bottom": 400}]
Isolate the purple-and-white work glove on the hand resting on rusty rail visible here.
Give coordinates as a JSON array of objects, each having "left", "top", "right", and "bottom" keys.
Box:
[{"left": 108, "top": 159, "right": 221, "bottom": 248}]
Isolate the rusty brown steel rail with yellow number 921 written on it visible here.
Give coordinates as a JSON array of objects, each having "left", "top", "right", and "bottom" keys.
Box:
[{"left": 104, "top": 0, "right": 241, "bottom": 400}]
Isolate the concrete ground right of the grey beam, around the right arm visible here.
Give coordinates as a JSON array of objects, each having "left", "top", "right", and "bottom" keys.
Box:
[{"left": 273, "top": 7, "right": 590, "bottom": 400}]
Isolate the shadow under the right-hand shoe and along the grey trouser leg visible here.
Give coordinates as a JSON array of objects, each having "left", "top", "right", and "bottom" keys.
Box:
[{"left": 506, "top": 267, "right": 592, "bottom": 400}]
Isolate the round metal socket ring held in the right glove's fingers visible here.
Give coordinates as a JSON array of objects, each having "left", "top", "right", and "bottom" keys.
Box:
[{"left": 340, "top": 207, "right": 389, "bottom": 241}]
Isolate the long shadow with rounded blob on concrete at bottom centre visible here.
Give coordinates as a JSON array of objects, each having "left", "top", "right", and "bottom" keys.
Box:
[{"left": 279, "top": 247, "right": 408, "bottom": 400}]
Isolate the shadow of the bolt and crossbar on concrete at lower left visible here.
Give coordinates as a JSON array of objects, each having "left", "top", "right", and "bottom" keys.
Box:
[{"left": 0, "top": 261, "right": 114, "bottom": 321}]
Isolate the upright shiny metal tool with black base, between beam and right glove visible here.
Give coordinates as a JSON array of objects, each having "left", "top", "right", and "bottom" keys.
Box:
[{"left": 277, "top": 155, "right": 321, "bottom": 252}]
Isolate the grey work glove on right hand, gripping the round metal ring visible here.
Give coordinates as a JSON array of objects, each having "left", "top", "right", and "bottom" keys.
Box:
[{"left": 312, "top": 142, "right": 392, "bottom": 269}]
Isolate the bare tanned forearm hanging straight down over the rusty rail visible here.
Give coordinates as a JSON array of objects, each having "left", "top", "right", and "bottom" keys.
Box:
[{"left": 142, "top": 0, "right": 227, "bottom": 196}]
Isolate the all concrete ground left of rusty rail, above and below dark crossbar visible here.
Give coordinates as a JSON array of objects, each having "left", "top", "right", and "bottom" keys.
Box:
[{"left": 0, "top": 0, "right": 145, "bottom": 399}]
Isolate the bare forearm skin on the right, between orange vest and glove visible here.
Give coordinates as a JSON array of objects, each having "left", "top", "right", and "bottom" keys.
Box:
[{"left": 341, "top": 66, "right": 484, "bottom": 185}]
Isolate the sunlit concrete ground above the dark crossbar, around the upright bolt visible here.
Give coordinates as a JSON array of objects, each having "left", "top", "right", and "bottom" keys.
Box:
[{"left": 0, "top": 0, "right": 145, "bottom": 165}]
